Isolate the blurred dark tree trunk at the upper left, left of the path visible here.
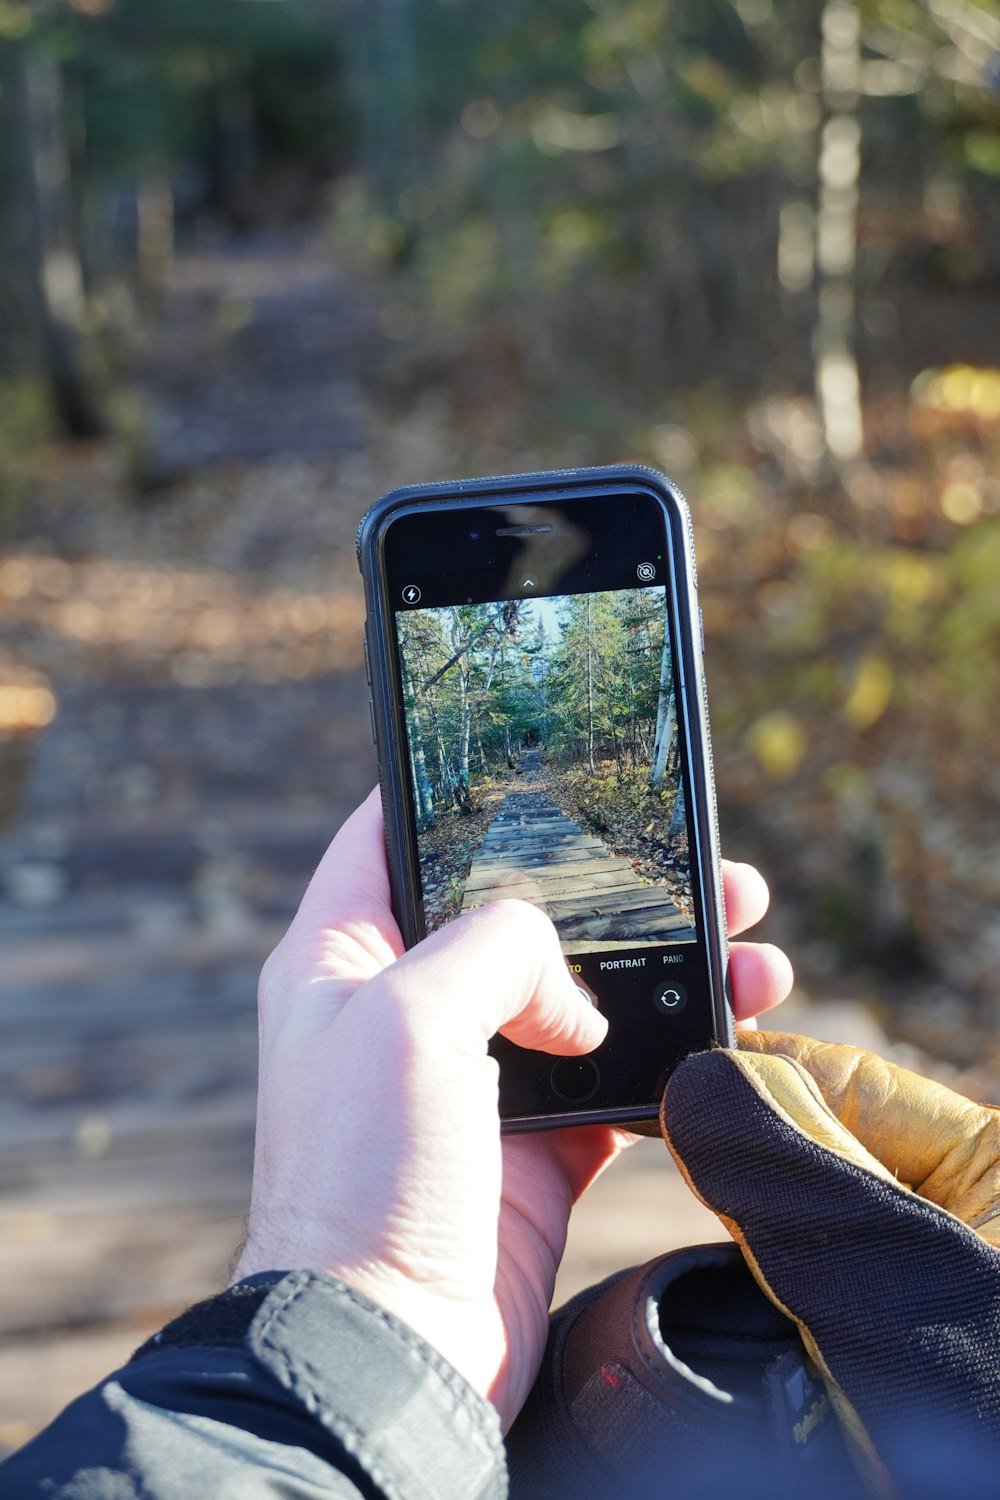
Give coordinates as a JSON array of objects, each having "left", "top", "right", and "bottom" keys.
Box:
[{"left": 19, "top": 45, "right": 103, "bottom": 438}]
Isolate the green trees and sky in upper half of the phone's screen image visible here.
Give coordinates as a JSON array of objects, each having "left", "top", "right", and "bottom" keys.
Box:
[{"left": 399, "top": 590, "right": 676, "bottom": 830}]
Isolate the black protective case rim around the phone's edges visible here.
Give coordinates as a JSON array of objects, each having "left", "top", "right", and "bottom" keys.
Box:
[{"left": 355, "top": 464, "right": 735, "bottom": 1136}]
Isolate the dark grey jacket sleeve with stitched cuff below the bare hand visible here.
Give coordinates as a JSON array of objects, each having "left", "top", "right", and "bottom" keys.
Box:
[{"left": 0, "top": 1271, "right": 507, "bottom": 1500}]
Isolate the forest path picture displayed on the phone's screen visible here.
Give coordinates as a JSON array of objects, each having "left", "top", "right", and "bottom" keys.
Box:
[{"left": 396, "top": 588, "right": 696, "bottom": 954}]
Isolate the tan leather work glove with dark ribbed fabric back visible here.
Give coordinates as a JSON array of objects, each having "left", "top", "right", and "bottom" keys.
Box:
[{"left": 661, "top": 1032, "right": 1000, "bottom": 1500}]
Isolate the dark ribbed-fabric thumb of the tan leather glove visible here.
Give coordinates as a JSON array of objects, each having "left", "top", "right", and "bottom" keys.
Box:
[{"left": 661, "top": 1050, "right": 1000, "bottom": 1494}]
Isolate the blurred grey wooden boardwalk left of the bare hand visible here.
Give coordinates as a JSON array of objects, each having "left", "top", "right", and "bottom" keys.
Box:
[{"left": 0, "top": 668, "right": 373, "bottom": 1440}]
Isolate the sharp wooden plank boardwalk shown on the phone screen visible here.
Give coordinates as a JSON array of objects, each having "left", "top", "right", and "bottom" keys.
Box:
[{"left": 462, "top": 788, "right": 694, "bottom": 948}]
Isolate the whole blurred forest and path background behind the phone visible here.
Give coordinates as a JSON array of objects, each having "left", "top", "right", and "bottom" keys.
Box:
[{"left": 0, "top": 0, "right": 1000, "bottom": 1442}]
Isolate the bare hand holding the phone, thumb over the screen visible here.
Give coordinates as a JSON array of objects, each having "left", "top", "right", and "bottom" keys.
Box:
[{"left": 234, "top": 794, "right": 790, "bottom": 1425}]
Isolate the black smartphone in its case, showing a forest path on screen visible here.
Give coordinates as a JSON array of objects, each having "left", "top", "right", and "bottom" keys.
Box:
[{"left": 358, "top": 465, "right": 733, "bottom": 1130}]
